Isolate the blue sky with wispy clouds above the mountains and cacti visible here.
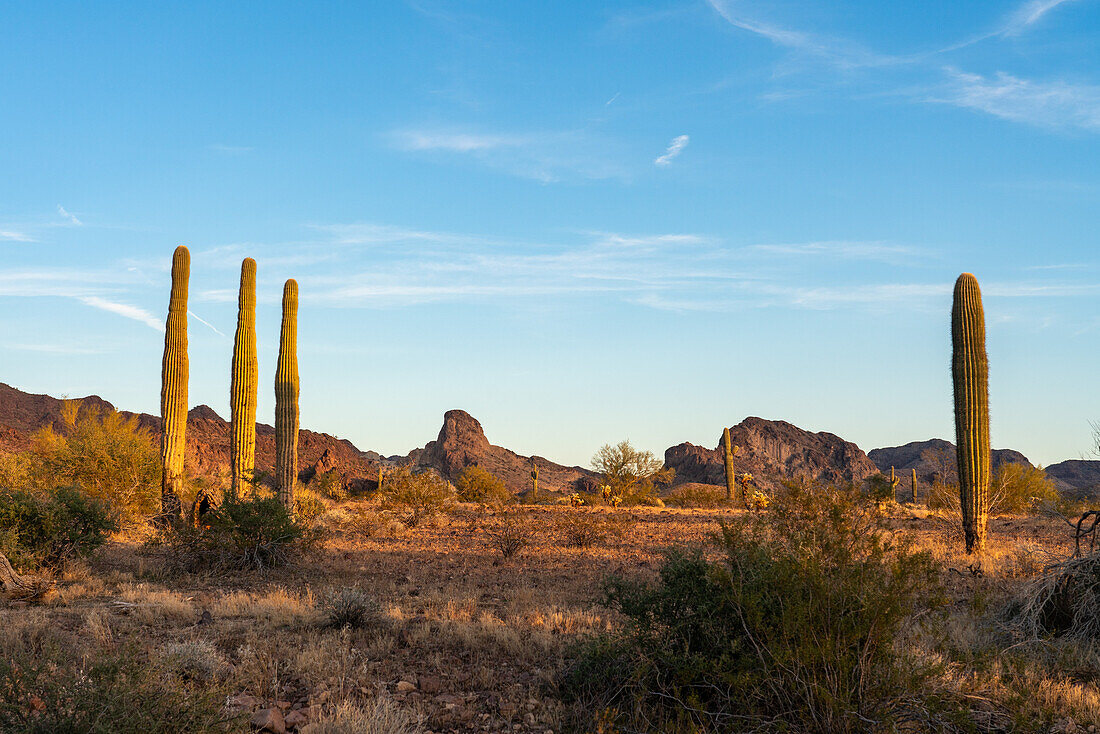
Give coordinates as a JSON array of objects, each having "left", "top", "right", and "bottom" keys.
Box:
[{"left": 0, "top": 0, "right": 1100, "bottom": 464}]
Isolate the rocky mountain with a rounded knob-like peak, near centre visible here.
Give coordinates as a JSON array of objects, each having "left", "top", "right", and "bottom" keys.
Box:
[{"left": 408, "top": 410, "right": 596, "bottom": 492}]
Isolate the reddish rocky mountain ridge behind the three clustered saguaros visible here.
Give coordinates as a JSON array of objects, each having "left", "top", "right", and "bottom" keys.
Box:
[{"left": 0, "top": 383, "right": 378, "bottom": 483}]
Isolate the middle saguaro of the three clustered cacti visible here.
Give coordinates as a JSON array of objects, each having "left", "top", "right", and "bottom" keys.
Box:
[{"left": 229, "top": 258, "right": 259, "bottom": 499}]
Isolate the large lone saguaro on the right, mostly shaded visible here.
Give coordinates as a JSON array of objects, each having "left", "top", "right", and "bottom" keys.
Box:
[{"left": 952, "top": 273, "right": 990, "bottom": 554}]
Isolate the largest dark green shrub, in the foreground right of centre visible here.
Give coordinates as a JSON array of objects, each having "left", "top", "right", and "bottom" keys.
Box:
[{"left": 564, "top": 487, "right": 939, "bottom": 732}]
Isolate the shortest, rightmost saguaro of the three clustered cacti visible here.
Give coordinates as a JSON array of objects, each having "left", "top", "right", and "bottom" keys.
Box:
[{"left": 275, "top": 278, "right": 298, "bottom": 510}]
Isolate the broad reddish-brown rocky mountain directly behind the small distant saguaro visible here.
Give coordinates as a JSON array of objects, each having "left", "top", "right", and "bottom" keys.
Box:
[{"left": 664, "top": 417, "right": 879, "bottom": 485}]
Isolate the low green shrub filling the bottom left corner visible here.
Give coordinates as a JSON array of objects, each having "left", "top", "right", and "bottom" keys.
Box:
[{"left": 0, "top": 640, "right": 241, "bottom": 734}]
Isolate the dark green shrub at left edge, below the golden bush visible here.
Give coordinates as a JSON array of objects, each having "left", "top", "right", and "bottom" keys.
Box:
[{"left": 0, "top": 487, "right": 118, "bottom": 572}]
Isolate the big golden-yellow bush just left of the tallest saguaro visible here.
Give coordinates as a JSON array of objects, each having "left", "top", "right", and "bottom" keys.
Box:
[{"left": 28, "top": 401, "right": 161, "bottom": 521}]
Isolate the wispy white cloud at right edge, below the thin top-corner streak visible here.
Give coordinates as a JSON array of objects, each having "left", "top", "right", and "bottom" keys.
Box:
[{"left": 932, "top": 68, "right": 1100, "bottom": 132}]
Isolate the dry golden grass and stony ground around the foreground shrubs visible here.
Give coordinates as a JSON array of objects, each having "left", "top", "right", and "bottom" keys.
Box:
[{"left": 0, "top": 501, "right": 1100, "bottom": 734}]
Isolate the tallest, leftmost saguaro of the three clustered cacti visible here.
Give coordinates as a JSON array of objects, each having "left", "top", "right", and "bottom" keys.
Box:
[{"left": 161, "top": 245, "right": 191, "bottom": 519}]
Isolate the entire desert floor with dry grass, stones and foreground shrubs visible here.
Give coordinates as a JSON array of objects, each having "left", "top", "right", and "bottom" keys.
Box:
[{"left": 0, "top": 484, "right": 1100, "bottom": 733}]
